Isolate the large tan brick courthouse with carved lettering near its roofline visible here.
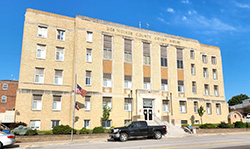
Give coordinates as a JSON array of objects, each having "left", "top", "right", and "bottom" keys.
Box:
[{"left": 16, "top": 9, "right": 228, "bottom": 130}]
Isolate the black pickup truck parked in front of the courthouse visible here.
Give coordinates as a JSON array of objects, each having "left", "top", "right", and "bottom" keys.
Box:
[{"left": 109, "top": 121, "right": 167, "bottom": 142}]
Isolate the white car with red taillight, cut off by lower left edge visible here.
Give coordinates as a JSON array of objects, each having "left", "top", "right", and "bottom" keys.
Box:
[{"left": 0, "top": 131, "right": 16, "bottom": 148}]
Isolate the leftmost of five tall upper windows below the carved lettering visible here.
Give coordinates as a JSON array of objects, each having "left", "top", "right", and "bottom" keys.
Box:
[{"left": 103, "top": 35, "right": 112, "bottom": 60}]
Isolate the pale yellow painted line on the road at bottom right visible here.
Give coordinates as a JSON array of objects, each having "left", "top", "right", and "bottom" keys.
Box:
[{"left": 152, "top": 141, "right": 250, "bottom": 149}]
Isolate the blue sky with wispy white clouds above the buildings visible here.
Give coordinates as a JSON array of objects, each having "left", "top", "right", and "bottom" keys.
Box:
[{"left": 0, "top": 0, "right": 250, "bottom": 100}]
